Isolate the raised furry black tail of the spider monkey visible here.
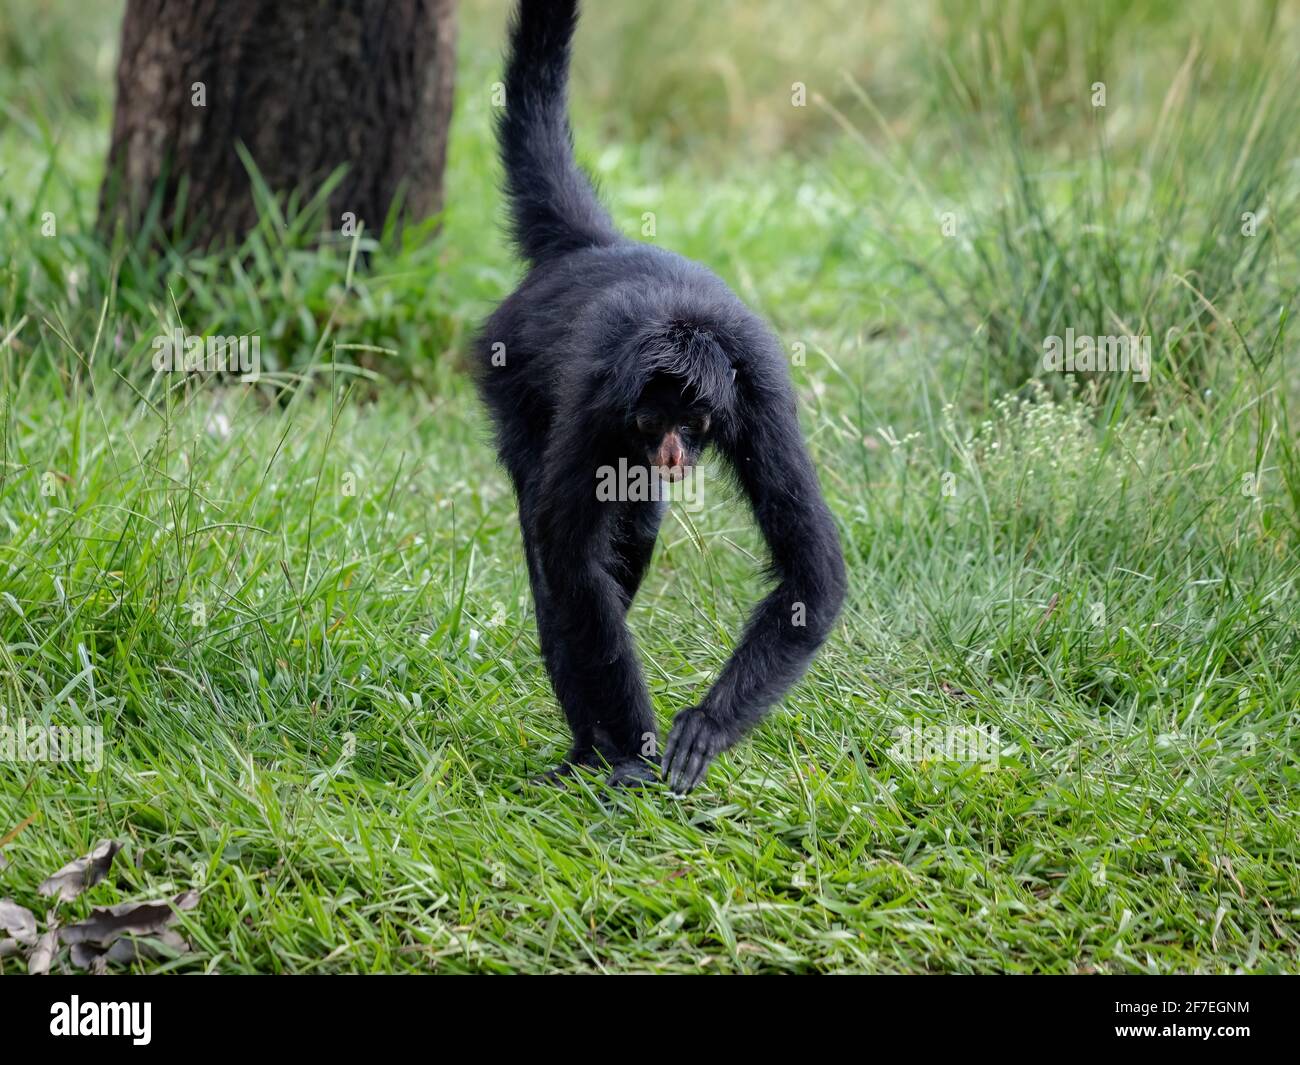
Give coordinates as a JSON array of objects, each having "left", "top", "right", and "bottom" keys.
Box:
[{"left": 497, "top": 0, "right": 619, "bottom": 263}]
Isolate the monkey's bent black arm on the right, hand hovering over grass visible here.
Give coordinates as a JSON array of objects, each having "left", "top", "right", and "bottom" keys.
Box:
[{"left": 663, "top": 389, "right": 845, "bottom": 792}]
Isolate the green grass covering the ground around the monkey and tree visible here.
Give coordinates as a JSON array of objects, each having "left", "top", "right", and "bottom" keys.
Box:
[{"left": 0, "top": 0, "right": 1300, "bottom": 973}]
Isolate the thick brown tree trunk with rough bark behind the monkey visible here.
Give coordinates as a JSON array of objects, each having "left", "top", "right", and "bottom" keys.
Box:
[{"left": 99, "top": 0, "right": 455, "bottom": 247}]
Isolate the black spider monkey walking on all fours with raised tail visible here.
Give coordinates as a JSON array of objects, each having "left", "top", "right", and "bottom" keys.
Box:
[{"left": 475, "top": 0, "right": 845, "bottom": 792}]
